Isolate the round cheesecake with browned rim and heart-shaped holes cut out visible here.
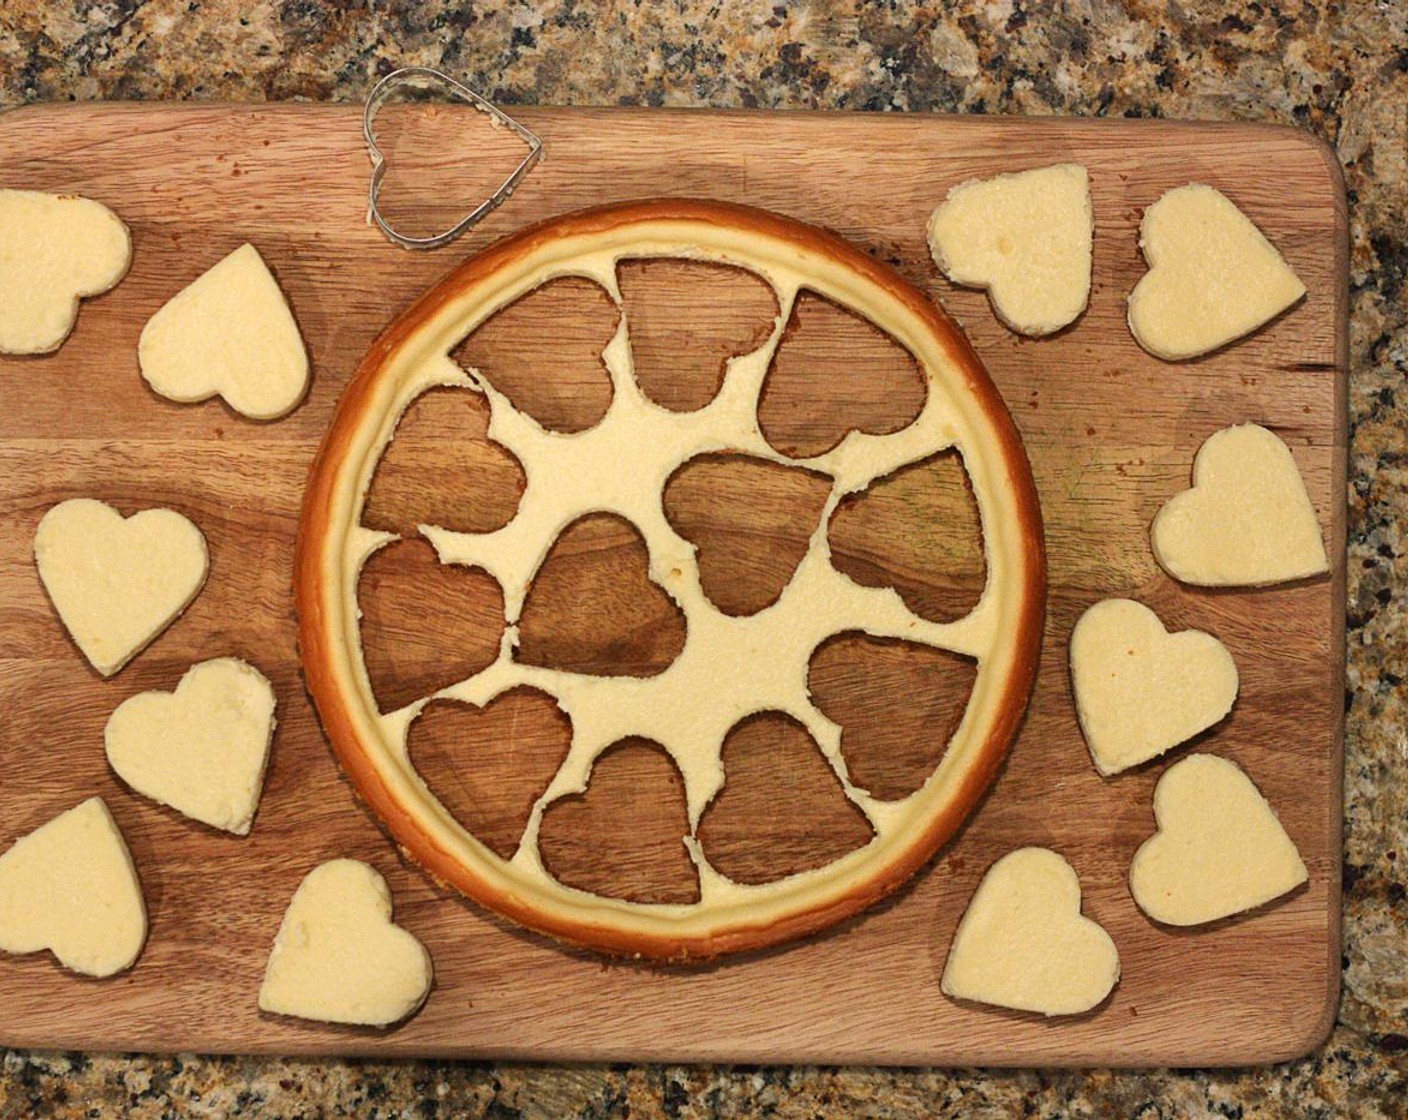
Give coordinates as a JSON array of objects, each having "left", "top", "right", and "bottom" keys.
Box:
[{"left": 296, "top": 199, "right": 1045, "bottom": 959}]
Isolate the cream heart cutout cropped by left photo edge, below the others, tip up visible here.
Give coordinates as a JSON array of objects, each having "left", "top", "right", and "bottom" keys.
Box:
[{"left": 0, "top": 797, "right": 146, "bottom": 976}]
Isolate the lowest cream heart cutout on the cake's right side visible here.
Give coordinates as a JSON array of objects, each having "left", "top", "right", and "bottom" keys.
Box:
[{"left": 939, "top": 848, "right": 1119, "bottom": 1016}]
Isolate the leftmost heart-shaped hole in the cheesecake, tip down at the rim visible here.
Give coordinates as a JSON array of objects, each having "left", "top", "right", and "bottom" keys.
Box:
[{"left": 358, "top": 541, "right": 504, "bottom": 711}]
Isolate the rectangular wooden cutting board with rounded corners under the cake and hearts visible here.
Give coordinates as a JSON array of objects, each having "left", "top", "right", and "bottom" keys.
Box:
[{"left": 0, "top": 104, "right": 1347, "bottom": 1065}]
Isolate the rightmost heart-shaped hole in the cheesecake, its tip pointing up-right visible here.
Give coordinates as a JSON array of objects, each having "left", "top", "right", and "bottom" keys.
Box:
[{"left": 826, "top": 451, "right": 987, "bottom": 623}]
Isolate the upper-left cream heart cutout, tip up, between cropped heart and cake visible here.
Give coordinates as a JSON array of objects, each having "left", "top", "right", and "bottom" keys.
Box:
[{"left": 137, "top": 244, "right": 308, "bottom": 420}]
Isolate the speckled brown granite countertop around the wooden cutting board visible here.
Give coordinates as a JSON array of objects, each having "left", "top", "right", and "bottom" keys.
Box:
[{"left": 0, "top": 0, "right": 1408, "bottom": 1117}]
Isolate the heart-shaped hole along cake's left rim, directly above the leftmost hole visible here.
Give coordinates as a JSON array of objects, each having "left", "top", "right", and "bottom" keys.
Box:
[{"left": 362, "top": 386, "right": 527, "bottom": 537}]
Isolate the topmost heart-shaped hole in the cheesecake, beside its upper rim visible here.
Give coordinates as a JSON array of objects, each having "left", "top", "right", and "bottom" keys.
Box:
[{"left": 617, "top": 258, "right": 777, "bottom": 413}]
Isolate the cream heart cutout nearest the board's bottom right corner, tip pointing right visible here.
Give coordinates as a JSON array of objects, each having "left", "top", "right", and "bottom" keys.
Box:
[{"left": 1129, "top": 755, "right": 1309, "bottom": 926}]
